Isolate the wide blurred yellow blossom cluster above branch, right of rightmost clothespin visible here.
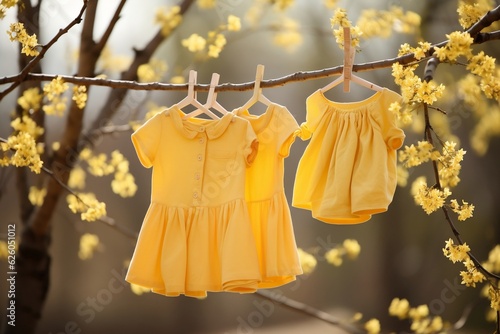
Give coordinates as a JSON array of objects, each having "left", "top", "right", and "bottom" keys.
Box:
[{"left": 356, "top": 6, "right": 421, "bottom": 38}]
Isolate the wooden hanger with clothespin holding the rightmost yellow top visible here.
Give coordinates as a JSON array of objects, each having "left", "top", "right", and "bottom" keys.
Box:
[{"left": 321, "top": 27, "right": 383, "bottom": 93}]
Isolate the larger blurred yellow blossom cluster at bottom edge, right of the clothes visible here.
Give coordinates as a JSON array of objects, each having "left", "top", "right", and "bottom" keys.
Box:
[{"left": 389, "top": 298, "right": 446, "bottom": 334}]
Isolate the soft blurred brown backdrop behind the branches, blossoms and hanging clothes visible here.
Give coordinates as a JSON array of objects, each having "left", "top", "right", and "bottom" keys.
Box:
[{"left": 0, "top": 0, "right": 500, "bottom": 334}]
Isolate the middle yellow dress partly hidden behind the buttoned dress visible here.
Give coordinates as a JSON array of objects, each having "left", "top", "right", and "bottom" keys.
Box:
[{"left": 235, "top": 103, "right": 302, "bottom": 288}]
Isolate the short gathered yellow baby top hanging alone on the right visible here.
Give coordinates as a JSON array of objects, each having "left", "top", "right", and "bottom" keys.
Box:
[{"left": 292, "top": 88, "right": 405, "bottom": 224}]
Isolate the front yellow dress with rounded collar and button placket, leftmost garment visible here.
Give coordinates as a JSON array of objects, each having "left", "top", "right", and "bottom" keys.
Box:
[{"left": 126, "top": 106, "right": 260, "bottom": 297}]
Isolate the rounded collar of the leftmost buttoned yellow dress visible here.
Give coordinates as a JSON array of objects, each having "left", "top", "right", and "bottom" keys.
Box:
[{"left": 165, "top": 105, "right": 234, "bottom": 139}]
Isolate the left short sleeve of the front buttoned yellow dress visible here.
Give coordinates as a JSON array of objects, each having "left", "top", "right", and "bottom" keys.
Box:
[{"left": 131, "top": 113, "right": 163, "bottom": 168}]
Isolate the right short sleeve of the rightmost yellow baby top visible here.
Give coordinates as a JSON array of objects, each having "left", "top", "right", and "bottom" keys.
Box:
[{"left": 375, "top": 90, "right": 405, "bottom": 150}]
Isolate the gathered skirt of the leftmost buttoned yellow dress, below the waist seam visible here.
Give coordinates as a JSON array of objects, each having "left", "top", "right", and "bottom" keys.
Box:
[{"left": 126, "top": 199, "right": 261, "bottom": 297}]
